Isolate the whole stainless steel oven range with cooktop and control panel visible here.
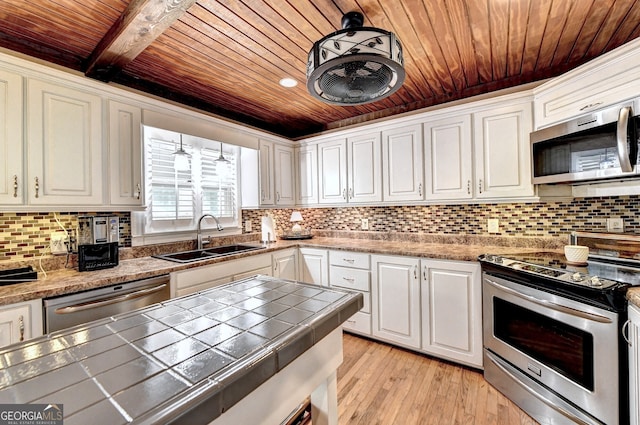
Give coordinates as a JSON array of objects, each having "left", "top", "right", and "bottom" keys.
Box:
[{"left": 479, "top": 233, "right": 640, "bottom": 425}]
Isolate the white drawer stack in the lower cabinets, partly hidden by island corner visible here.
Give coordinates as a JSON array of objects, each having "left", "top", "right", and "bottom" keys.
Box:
[{"left": 329, "top": 251, "right": 371, "bottom": 336}]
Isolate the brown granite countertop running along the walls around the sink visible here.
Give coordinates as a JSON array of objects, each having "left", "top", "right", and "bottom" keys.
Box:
[{"left": 0, "top": 236, "right": 562, "bottom": 306}]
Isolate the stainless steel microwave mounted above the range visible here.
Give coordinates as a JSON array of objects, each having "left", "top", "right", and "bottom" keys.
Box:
[{"left": 530, "top": 102, "right": 640, "bottom": 184}]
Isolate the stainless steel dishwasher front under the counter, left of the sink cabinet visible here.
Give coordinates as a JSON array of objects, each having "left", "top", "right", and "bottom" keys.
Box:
[{"left": 43, "top": 275, "right": 170, "bottom": 333}]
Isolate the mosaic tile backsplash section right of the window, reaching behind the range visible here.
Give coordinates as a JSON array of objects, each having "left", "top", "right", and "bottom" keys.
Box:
[{"left": 242, "top": 196, "right": 640, "bottom": 237}]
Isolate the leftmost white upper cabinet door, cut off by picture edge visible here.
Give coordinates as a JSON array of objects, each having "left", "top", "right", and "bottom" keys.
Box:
[{"left": 0, "top": 70, "right": 25, "bottom": 205}]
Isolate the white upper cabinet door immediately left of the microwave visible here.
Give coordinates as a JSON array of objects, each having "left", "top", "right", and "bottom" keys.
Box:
[{"left": 473, "top": 102, "right": 534, "bottom": 198}]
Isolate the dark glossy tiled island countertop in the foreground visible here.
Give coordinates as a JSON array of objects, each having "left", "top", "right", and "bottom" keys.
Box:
[{"left": 0, "top": 276, "right": 363, "bottom": 425}]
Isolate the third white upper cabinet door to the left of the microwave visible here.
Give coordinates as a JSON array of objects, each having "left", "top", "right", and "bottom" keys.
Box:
[{"left": 382, "top": 124, "right": 424, "bottom": 201}]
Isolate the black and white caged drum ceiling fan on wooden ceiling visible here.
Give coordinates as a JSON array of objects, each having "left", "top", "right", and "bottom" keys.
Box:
[{"left": 307, "top": 12, "right": 405, "bottom": 106}]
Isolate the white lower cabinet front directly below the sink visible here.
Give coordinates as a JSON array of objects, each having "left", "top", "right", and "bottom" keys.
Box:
[{"left": 170, "top": 254, "right": 272, "bottom": 298}]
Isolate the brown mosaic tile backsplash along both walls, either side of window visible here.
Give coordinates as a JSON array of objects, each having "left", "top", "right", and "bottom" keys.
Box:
[{"left": 0, "top": 196, "right": 640, "bottom": 261}]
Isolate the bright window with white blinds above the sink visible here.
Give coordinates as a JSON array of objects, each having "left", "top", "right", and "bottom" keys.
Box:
[{"left": 144, "top": 127, "right": 239, "bottom": 233}]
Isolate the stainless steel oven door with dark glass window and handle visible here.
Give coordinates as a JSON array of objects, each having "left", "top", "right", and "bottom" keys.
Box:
[{"left": 483, "top": 273, "right": 619, "bottom": 424}]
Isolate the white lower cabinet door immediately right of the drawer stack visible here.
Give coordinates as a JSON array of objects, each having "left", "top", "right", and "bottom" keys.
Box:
[{"left": 371, "top": 256, "right": 420, "bottom": 348}]
